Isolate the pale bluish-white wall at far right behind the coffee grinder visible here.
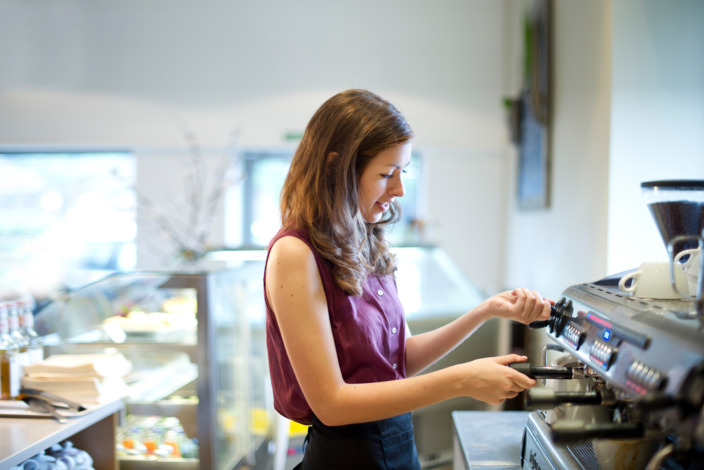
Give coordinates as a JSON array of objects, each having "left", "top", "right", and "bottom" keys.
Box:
[{"left": 608, "top": 0, "right": 704, "bottom": 272}]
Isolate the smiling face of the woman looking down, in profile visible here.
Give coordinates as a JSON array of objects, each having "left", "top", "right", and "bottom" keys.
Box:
[{"left": 359, "top": 142, "right": 412, "bottom": 223}]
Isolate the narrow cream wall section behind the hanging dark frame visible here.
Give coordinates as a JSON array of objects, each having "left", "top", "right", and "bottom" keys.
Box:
[{"left": 506, "top": 0, "right": 611, "bottom": 299}]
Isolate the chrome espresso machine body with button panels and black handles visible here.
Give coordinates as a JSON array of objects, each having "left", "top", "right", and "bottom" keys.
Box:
[{"left": 521, "top": 278, "right": 704, "bottom": 469}]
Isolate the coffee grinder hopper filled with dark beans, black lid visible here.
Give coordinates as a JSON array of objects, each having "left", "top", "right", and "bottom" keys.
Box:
[{"left": 640, "top": 180, "right": 704, "bottom": 312}]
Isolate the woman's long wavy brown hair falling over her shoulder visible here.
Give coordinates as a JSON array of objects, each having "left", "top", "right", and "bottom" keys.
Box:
[{"left": 281, "top": 90, "right": 413, "bottom": 295}]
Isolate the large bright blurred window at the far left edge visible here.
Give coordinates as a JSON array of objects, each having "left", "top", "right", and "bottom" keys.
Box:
[{"left": 0, "top": 151, "right": 137, "bottom": 293}]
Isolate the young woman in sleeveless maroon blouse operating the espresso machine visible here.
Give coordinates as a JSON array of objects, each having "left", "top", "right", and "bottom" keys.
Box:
[{"left": 264, "top": 90, "right": 550, "bottom": 470}]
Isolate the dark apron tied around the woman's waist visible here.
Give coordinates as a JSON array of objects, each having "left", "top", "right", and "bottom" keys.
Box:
[{"left": 294, "top": 413, "right": 420, "bottom": 470}]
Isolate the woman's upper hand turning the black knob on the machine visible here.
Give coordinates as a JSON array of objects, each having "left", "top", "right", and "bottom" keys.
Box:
[{"left": 485, "top": 288, "right": 555, "bottom": 324}]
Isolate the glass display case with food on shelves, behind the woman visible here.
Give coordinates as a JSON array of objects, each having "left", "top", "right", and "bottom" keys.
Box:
[{"left": 36, "top": 260, "right": 273, "bottom": 470}]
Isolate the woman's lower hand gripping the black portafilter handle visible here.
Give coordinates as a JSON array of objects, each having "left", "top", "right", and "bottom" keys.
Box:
[{"left": 456, "top": 354, "right": 536, "bottom": 405}]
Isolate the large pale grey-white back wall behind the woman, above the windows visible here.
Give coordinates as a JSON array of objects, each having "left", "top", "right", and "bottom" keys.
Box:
[{"left": 0, "top": 0, "right": 509, "bottom": 290}]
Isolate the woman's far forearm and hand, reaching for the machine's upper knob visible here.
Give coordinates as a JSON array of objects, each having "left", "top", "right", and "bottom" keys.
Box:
[{"left": 406, "top": 289, "right": 554, "bottom": 377}]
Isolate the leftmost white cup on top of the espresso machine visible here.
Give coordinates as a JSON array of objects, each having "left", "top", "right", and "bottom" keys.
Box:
[{"left": 618, "top": 262, "right": 689, "bottom": 299}]
